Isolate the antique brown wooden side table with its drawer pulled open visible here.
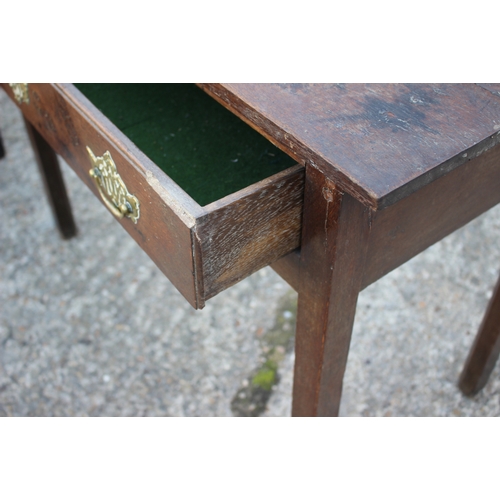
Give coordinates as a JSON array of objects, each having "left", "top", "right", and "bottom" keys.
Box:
[{"left": 0, "top": 84, "right": 500, "bottom": 416}]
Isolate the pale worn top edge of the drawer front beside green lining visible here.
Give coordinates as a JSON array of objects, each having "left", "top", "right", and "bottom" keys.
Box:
[{"left": 57, "top": 83, "right": 204, "bottom": 227}]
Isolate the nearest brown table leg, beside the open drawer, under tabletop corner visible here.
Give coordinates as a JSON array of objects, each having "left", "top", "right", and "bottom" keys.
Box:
[{"left": 292, "top": 167, "right": 371, "bottom": 416}]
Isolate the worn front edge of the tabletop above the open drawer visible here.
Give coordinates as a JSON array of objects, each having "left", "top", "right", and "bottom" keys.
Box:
[{"left": 197, "top": 83, "right": 377, "bottom": 208}]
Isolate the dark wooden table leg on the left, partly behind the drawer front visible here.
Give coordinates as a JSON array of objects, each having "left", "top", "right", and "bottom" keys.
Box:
[{"left": 24, "top": 119, "right": 77, "bottom": 238}]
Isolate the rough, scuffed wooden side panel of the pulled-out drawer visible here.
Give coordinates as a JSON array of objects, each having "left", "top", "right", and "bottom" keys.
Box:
[{"left": 194, "top": 165, "right": 305, "bottom": 300}]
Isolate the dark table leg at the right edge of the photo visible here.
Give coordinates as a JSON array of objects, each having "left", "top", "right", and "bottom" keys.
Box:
[{"left": 458, "top": 270, "right": 500, "bottom": 395}]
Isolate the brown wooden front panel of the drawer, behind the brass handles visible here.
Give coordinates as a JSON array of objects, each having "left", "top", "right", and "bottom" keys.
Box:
[{"left": 4, "top": 84, "right": 202, "bottom": 307}]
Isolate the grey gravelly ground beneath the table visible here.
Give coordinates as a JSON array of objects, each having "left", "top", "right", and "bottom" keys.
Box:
[{"left": 0, "top": 88, "right": 500, "bottom": 417}]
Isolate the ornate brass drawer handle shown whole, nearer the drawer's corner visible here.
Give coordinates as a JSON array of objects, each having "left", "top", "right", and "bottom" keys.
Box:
[{"left": 87, "top": 146, "right": 140, "bottom": 224}]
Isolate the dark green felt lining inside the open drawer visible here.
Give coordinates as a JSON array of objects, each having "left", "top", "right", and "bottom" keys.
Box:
[{"left": 75, "top": 83, "right": 296, "bottom": 206}]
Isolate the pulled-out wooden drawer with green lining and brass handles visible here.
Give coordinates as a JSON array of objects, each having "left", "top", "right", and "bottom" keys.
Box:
[{"left": 3, "top": 84, "right": 304, "bottom": 308}]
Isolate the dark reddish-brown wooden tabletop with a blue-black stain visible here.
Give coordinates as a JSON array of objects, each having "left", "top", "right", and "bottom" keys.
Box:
[{"left": 201, "top": 84, "right": 500, "bottom": 209}]
